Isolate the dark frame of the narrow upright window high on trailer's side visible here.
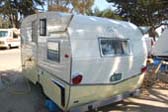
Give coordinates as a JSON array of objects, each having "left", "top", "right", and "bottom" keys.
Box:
[{"left": 39, "top": 18, "right": 47, "bottom": 36}]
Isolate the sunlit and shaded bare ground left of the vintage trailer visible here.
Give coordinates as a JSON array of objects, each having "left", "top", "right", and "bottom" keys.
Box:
[{"left": 0, "top": 48, "right": 48, "bottom": 112}]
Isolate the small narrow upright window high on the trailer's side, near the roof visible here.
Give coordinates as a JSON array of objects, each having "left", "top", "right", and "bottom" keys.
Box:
[{"left": 39, "top": 19, "right": 47, "bottom": 36}]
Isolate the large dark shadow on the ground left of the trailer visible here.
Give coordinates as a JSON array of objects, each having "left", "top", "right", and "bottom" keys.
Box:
[{"left": 0, "top": 71, "right": 48, "bottom": 112}]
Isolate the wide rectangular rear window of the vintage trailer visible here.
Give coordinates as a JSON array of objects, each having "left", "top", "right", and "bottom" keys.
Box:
[{"left": 99, "top": 38, "right": 130, "bottom": 56}]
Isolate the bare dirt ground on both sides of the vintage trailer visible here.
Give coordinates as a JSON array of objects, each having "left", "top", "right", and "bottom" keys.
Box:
[{"left": 0, "top": 48, "right": 168, "bottom": 112}]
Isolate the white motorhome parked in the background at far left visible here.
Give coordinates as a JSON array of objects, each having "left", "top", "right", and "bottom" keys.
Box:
[{"left": 0, "top": 28, "right": 20, "bottom": 48}]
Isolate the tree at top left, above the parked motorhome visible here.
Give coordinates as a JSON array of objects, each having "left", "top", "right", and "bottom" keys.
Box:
[{"left": 0, "top": 0, "right": 44, "bottom": 28}]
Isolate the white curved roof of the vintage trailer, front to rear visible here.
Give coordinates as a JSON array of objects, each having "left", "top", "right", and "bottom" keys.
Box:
[{"left": 22, "top": 12, "right": 142, "bottom": 40}]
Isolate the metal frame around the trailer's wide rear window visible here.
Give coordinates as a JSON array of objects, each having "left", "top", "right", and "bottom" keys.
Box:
[{"left": 98, "top": 37, "right": 132, "bottom": 57}]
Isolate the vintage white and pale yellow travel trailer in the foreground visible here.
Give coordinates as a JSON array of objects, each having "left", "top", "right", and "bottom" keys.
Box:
[{"left": 21, "top": 12, "right": 147, "bottom": 112}]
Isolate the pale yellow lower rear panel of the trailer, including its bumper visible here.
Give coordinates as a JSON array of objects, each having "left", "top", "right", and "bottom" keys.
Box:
[{"left": 68, "top": 74, "right": 144, "bottom": 112}]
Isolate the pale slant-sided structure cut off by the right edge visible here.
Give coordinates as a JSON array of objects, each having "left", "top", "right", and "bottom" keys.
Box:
[{"left": 152, "top": 29, "right": 168, "bottom": 60}]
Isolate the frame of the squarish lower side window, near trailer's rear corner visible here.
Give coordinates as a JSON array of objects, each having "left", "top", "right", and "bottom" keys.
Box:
[{"left": 46, "top": 41, "right": 61, "bottom": 63}]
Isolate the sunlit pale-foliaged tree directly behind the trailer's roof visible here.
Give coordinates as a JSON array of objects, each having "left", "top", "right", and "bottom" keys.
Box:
[{"left": 48, "top": 0, "right": 94, "bottom": 14}]
